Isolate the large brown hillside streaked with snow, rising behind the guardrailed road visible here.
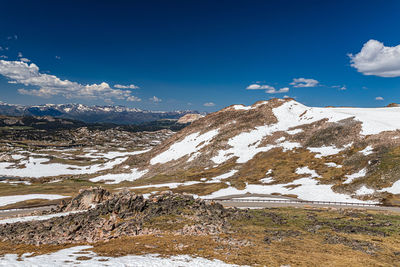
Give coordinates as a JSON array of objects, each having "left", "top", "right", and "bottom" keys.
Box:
[{"left": 109, "top": 99, "right": 400, "bottom": 204}]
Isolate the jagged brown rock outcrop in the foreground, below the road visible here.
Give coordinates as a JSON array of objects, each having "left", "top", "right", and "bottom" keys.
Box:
[{"left": 0, "top": 188, "right": 231, "bottom": 245}]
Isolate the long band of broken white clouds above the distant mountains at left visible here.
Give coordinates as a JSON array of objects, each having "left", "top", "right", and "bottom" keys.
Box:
[{"left": 0, "top": 60, "right": 141, "bottom": 101}]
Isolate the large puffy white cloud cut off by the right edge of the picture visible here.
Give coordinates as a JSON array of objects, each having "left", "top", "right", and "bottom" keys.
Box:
[{"left": 349, "top": 39, "right": 400, "bottom": 77}]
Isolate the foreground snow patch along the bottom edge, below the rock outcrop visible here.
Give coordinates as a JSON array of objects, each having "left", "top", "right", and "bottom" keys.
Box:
[{"left": 0, "top": 246, "right": 238, "bottom": 267}]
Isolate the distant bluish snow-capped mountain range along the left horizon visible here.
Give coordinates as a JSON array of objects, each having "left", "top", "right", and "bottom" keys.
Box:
[{"left": 0, "top": 102, "right": 199, "bottom": 124}]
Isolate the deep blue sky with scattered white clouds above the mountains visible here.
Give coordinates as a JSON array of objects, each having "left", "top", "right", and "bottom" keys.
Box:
[{"left": 0, "top": 0, "right": 400, "bottom": 111}]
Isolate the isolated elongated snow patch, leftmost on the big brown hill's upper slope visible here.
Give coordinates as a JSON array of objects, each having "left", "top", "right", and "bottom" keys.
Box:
[{"left": 150, "top": 129, "right": 219, "bottom": 165}]
